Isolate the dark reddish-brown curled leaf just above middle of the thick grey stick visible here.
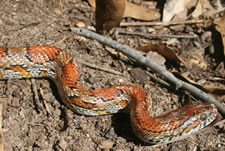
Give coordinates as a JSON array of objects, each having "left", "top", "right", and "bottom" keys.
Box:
[{"left": 137, "top": 44, "right": 187, "bottom": 65}]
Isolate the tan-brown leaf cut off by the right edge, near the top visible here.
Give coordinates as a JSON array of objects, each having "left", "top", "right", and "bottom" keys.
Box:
[{"left": 216, "top": 11, "right": 225, "bottom": 56}]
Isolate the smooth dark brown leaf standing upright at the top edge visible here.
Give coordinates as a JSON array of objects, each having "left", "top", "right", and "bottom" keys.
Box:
[{"left": 95, "top": 0, "right": 126, "bottom": 34}]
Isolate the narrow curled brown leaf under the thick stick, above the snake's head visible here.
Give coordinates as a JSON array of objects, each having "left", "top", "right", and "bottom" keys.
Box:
[{"left": 173, "top": 72, "right": 225, "bottom": 96}]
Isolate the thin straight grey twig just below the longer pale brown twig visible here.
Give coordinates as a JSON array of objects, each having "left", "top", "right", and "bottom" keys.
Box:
[{"left": 118, "top": 31, "right": 197, "bottom": 39}]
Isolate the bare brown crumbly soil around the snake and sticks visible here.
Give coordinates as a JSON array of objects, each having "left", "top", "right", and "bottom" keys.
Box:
[{"left": 0, "top": 0, "right": 225, "bottom": 151}]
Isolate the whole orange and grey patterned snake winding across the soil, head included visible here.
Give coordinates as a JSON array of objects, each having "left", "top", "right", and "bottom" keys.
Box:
[{"left": 0, "top": 46, "right": 218, "bottom": 144}]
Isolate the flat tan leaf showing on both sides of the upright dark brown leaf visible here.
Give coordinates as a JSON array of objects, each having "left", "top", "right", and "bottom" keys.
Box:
[{"left": 88, "top": 0, "right": 161, "bottom": 21}]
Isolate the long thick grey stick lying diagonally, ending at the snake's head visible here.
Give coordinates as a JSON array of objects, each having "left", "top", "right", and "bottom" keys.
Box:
[{"left": 71, "top": 27, "right": 225, "bottom": 116}]
